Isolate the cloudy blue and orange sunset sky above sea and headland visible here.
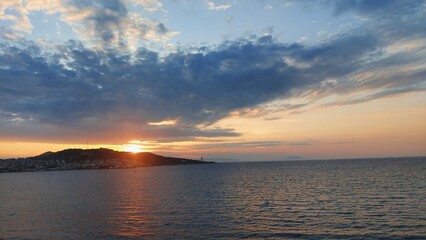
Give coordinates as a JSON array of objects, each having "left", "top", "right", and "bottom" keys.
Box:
[{"left": 0, "top": 0, "right": 426, "bottom": 161}]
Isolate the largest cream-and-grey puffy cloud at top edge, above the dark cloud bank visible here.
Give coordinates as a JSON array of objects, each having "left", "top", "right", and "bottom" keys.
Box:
[{"left": 62, "top": 0, "right": 176, "bottom": 49}]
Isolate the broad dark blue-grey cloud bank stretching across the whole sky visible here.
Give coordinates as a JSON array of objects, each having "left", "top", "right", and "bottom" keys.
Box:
[{"left": 0, "top": 1, "right": 426, "bottom": 142}]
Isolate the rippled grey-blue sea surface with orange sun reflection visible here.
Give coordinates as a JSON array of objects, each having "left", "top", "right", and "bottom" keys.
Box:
[{"left": 0, "top": 158, "right": 426, "bottom": 239}]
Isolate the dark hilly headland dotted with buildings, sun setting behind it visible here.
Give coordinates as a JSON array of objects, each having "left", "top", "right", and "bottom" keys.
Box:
[{"left": 0, "top": 148, "right": 213, "bottom": 172}]
